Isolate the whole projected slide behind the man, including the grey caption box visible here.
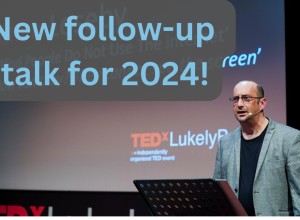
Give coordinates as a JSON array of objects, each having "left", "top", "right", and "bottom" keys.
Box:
[{"left": 0, "top": 0, "right": 286, "bottom": 191}]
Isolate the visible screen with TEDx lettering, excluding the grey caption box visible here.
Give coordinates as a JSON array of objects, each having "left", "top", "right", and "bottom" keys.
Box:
[{"left": 0, "top": 0, "right": 286, "bottom": 216}]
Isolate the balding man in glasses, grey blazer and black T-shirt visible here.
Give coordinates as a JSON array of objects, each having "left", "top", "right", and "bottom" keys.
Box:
[{"left": 214, "top": 81, "right": 300, "bottom": 216}]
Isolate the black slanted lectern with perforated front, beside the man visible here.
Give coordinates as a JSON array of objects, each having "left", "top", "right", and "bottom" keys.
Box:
[{"left": 133, "top": 179, "right": 247, "bottom": 216}]
